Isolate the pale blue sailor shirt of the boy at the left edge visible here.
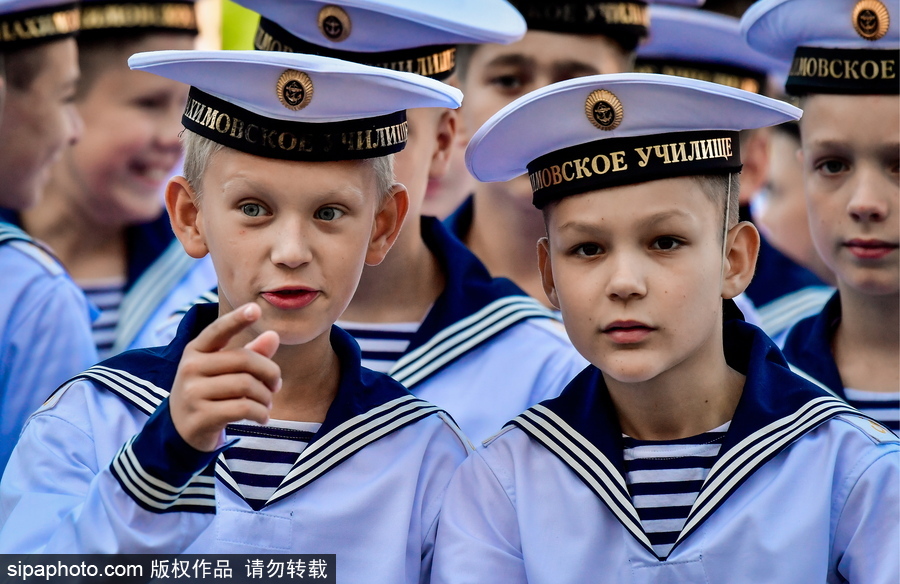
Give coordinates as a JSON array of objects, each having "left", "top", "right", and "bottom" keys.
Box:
[{"left": 0, "top": 222, "right": 97, "bottom": 472}]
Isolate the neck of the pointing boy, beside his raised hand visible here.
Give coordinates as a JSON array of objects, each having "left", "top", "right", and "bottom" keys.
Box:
[{"left": 270, "top": 330, "right": 340, "bottom": 423}]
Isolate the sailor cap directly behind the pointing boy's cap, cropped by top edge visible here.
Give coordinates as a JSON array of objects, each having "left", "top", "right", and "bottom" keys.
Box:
[{"left": 238, "top": 0, "right": 525, "bottom": 80}]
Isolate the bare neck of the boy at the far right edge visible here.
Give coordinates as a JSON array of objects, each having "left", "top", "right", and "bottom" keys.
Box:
[{"left": 831, "top": 282, "right": 900, "bottom": 392}]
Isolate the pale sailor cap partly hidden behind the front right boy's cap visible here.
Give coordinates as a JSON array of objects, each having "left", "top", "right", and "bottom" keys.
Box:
[{"left": 634, "top": 5, "right": 790, "bottom": 93}]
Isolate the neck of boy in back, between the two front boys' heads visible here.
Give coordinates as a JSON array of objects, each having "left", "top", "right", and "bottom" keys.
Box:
[{"left": 465, "top": 183, "right": 550, "bottom": 306}]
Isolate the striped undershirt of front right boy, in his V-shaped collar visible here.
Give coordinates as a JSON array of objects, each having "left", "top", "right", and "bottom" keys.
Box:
[{"left": 623, "top": 422, "right": 731, "bottom": 558}]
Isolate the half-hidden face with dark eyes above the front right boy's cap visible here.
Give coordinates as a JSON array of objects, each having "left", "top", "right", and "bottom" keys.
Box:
[{"left": 460, "top": 30, "right": 630, "bottom": 206}]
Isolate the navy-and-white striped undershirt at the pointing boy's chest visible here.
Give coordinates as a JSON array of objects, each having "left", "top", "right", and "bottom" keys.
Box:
[{"left": 225, "top": 420, "right": 322, "bottom": 511}]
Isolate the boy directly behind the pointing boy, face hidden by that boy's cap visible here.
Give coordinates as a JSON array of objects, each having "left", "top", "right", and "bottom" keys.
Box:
[{"left": 160, "top": 0, "right": 585, "bottom": 441}]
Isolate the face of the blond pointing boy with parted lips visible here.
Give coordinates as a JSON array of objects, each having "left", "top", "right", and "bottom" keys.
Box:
[{"left": 183, "top": 149, "right": 402, "bottom": 345}]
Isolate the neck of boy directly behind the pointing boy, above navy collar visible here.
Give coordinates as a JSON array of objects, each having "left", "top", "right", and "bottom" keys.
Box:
[{"left": 341, "top": 217, "right": 445, "bottom": 323}]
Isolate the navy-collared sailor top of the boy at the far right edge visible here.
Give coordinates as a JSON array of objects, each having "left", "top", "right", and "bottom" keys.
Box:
[{"left": 782, "top": 292, "right": 900, "bottom": 433}]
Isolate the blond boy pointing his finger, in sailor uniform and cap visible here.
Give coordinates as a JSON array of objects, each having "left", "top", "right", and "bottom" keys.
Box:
[{"left": 0, "top": 51, "right": 467, "bottom": 584}]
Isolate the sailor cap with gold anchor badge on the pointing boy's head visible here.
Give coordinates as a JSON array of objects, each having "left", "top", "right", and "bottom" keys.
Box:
[{"left": 128, "top": 51, "right": 462, "bottom": 161}]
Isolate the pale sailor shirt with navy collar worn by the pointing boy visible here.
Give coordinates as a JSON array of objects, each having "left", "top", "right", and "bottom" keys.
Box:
[{"left": 0, "top": 304, "right": 468, "bottom": 584}]
